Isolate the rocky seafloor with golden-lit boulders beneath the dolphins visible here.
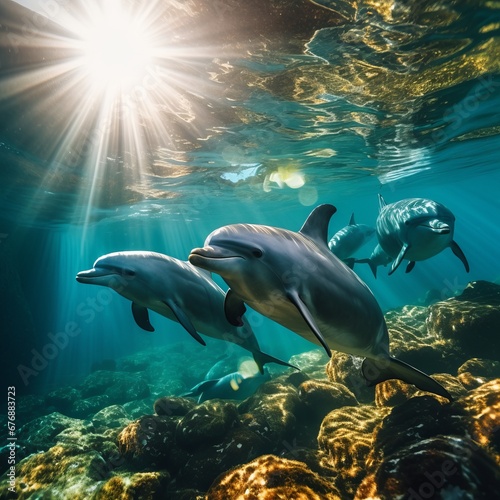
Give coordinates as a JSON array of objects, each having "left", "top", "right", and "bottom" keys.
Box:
[{"left": 0, "top": 281, "right": 500, "bottom": 500}]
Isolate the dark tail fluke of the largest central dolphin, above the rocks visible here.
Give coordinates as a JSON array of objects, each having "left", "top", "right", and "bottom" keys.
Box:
[{"left": 361, "top": 357, "right": 453, "bottom": 401}]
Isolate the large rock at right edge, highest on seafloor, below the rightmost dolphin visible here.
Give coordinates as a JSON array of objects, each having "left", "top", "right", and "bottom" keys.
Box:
[{"left": 427, "top": 281, "right": 500, "bottom": 362}]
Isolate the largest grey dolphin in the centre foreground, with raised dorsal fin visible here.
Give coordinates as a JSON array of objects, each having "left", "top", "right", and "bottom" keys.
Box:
[{"left": 189, "top": 205, "right": 451, "bottom": 399}]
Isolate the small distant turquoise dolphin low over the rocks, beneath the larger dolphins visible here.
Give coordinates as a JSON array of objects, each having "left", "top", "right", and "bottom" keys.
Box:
[{"left": 181, "top": 370, "right": 271, "bottom": 403}]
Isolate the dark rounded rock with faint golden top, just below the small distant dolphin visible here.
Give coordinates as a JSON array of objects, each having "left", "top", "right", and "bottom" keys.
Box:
[{"left": 175, "top": 399, "right": 239, "bottom": 451}]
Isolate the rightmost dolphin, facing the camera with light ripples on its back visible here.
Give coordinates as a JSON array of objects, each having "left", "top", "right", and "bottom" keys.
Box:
[{"left": 377, "top": 194, "right": 469, "bottom": 274}]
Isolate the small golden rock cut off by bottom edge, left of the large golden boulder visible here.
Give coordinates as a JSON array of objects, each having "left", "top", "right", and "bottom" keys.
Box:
[{"left": 96, "top": 471, "right": 170, "bottom": 500}]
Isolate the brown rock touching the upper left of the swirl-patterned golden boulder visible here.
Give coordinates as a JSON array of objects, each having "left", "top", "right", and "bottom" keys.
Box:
[{"left": 299, "top": 380, "right": 358, "bottom": 424}]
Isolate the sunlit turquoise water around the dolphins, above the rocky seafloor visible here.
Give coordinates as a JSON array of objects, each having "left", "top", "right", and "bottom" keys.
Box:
[{"left": 0, "top": 1, "right": 500, "bottom": 398}]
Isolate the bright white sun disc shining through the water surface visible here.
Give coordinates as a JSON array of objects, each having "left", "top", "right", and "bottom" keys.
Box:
[{"left": 81, "top": 0, "right": 154, "bottom": 91}]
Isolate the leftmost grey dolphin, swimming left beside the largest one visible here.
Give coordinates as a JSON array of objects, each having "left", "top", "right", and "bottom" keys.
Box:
[{"left": 76, "top": 251, "right": 295, "bottom": 372}]
